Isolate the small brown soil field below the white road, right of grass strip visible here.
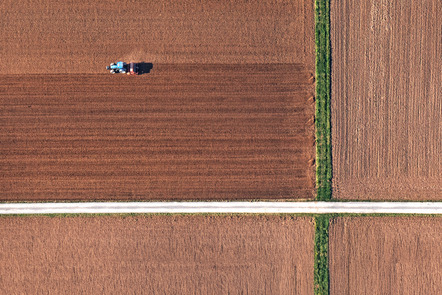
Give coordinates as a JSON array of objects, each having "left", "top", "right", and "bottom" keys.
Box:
[{"left": 329, "top": 217, "right": 442, "bottom": 295}]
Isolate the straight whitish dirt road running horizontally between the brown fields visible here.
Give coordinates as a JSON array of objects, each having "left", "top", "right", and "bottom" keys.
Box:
[{"left": 0, "top": 202, "right": 442, "bottom": 214}]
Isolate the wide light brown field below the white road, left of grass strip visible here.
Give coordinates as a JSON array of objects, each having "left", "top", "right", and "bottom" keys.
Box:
[{"left": 0, "top": 216, "right": 314, "bottom": 294}]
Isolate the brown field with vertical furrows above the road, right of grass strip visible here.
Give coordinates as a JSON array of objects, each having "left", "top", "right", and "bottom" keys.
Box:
[{"left": 331, "top": 0, "right": 442, "bottom": 200}]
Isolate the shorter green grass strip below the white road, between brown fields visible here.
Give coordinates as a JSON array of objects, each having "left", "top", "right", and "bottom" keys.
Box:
[{"left": 314, "top": 215, "right": 330, "bottom": 295}]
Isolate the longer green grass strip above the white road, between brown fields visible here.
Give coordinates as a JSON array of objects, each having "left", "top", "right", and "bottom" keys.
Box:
[{"left": 315, "top": 0, "right": 332, "bottom": 201}]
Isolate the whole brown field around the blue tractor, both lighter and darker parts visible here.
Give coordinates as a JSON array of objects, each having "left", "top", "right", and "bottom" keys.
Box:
[{"left": 0, "top": 0, "right": 315, "bottom": 201}]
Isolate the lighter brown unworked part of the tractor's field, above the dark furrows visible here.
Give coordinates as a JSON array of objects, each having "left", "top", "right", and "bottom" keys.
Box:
[{"left": 0, "top": 0, "right": 314, "bottom": 74}]
